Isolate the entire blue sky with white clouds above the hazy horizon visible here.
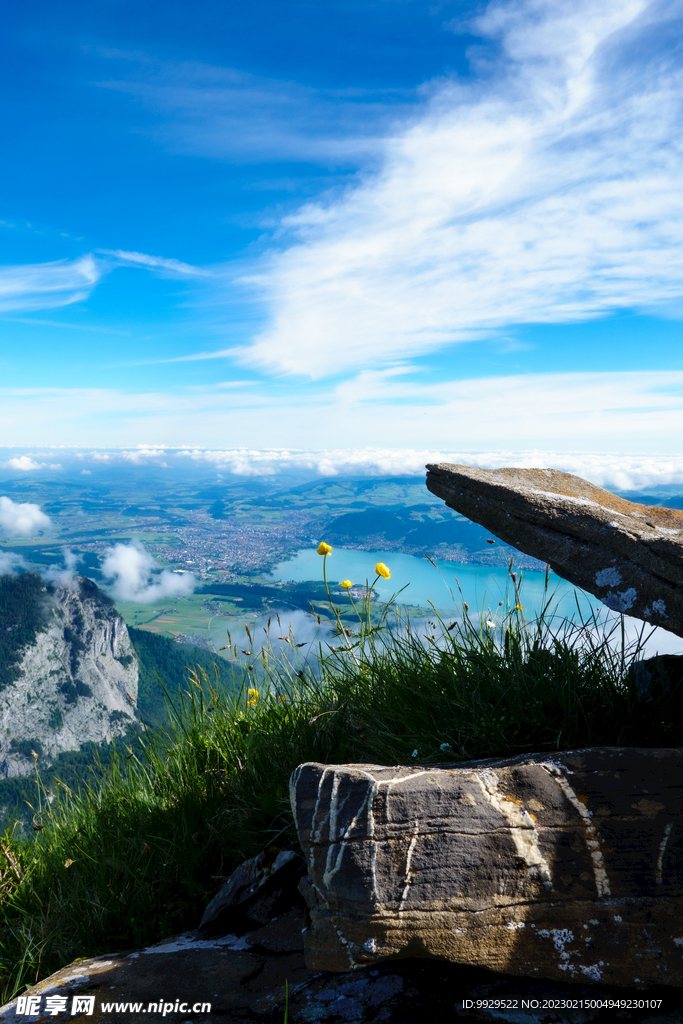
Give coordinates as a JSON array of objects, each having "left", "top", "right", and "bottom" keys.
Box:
[{"left": 0, "top": 0, "right": 683, "bottom": 456}]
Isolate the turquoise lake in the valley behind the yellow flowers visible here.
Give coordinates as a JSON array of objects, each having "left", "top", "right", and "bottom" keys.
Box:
[{"left": 269, "top": 548, "right": 606, "bottom": 621}]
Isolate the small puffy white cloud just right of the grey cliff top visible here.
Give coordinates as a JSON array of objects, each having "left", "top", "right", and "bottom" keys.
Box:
[{"left": 102, "top": 541, "right": 197, "bottom": 604}]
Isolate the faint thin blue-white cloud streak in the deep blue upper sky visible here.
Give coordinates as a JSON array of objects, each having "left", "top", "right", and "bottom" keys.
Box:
[{"left": 99, "top": 49, "right": 415, "bottom": 167}]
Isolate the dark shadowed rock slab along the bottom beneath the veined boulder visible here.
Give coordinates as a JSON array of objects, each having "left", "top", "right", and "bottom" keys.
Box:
[{"left": 5, "top": 909, "right": 683, "bottom": 1024}]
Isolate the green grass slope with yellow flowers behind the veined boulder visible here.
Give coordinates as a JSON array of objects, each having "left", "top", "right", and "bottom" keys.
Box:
[{"left": 0, "top": 581, "right": 683, "bottom": 1001}]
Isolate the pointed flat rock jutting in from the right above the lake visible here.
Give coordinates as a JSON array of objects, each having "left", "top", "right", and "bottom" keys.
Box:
[{"left": 427, "top": 463, "right": 683, "bottom": 636}]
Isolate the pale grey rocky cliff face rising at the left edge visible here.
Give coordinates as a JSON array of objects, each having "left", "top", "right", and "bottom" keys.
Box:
[{"left": 0, "top": 573, "right": 138, "bottom": 778}]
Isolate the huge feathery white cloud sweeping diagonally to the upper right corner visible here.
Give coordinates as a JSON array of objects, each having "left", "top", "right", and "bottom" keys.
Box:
[{"left": 243, "top": 0, "right": 683, "bottom": 377}]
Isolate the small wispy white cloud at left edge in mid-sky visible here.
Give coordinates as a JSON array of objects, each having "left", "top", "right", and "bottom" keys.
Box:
[{"left": 0, "top": 256, "right": 100, "bottom": 311}]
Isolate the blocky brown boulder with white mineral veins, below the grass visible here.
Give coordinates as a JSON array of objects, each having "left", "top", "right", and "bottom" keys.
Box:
[{"left": 291, "top": 748, "right": 683, "bottom": 987}]
